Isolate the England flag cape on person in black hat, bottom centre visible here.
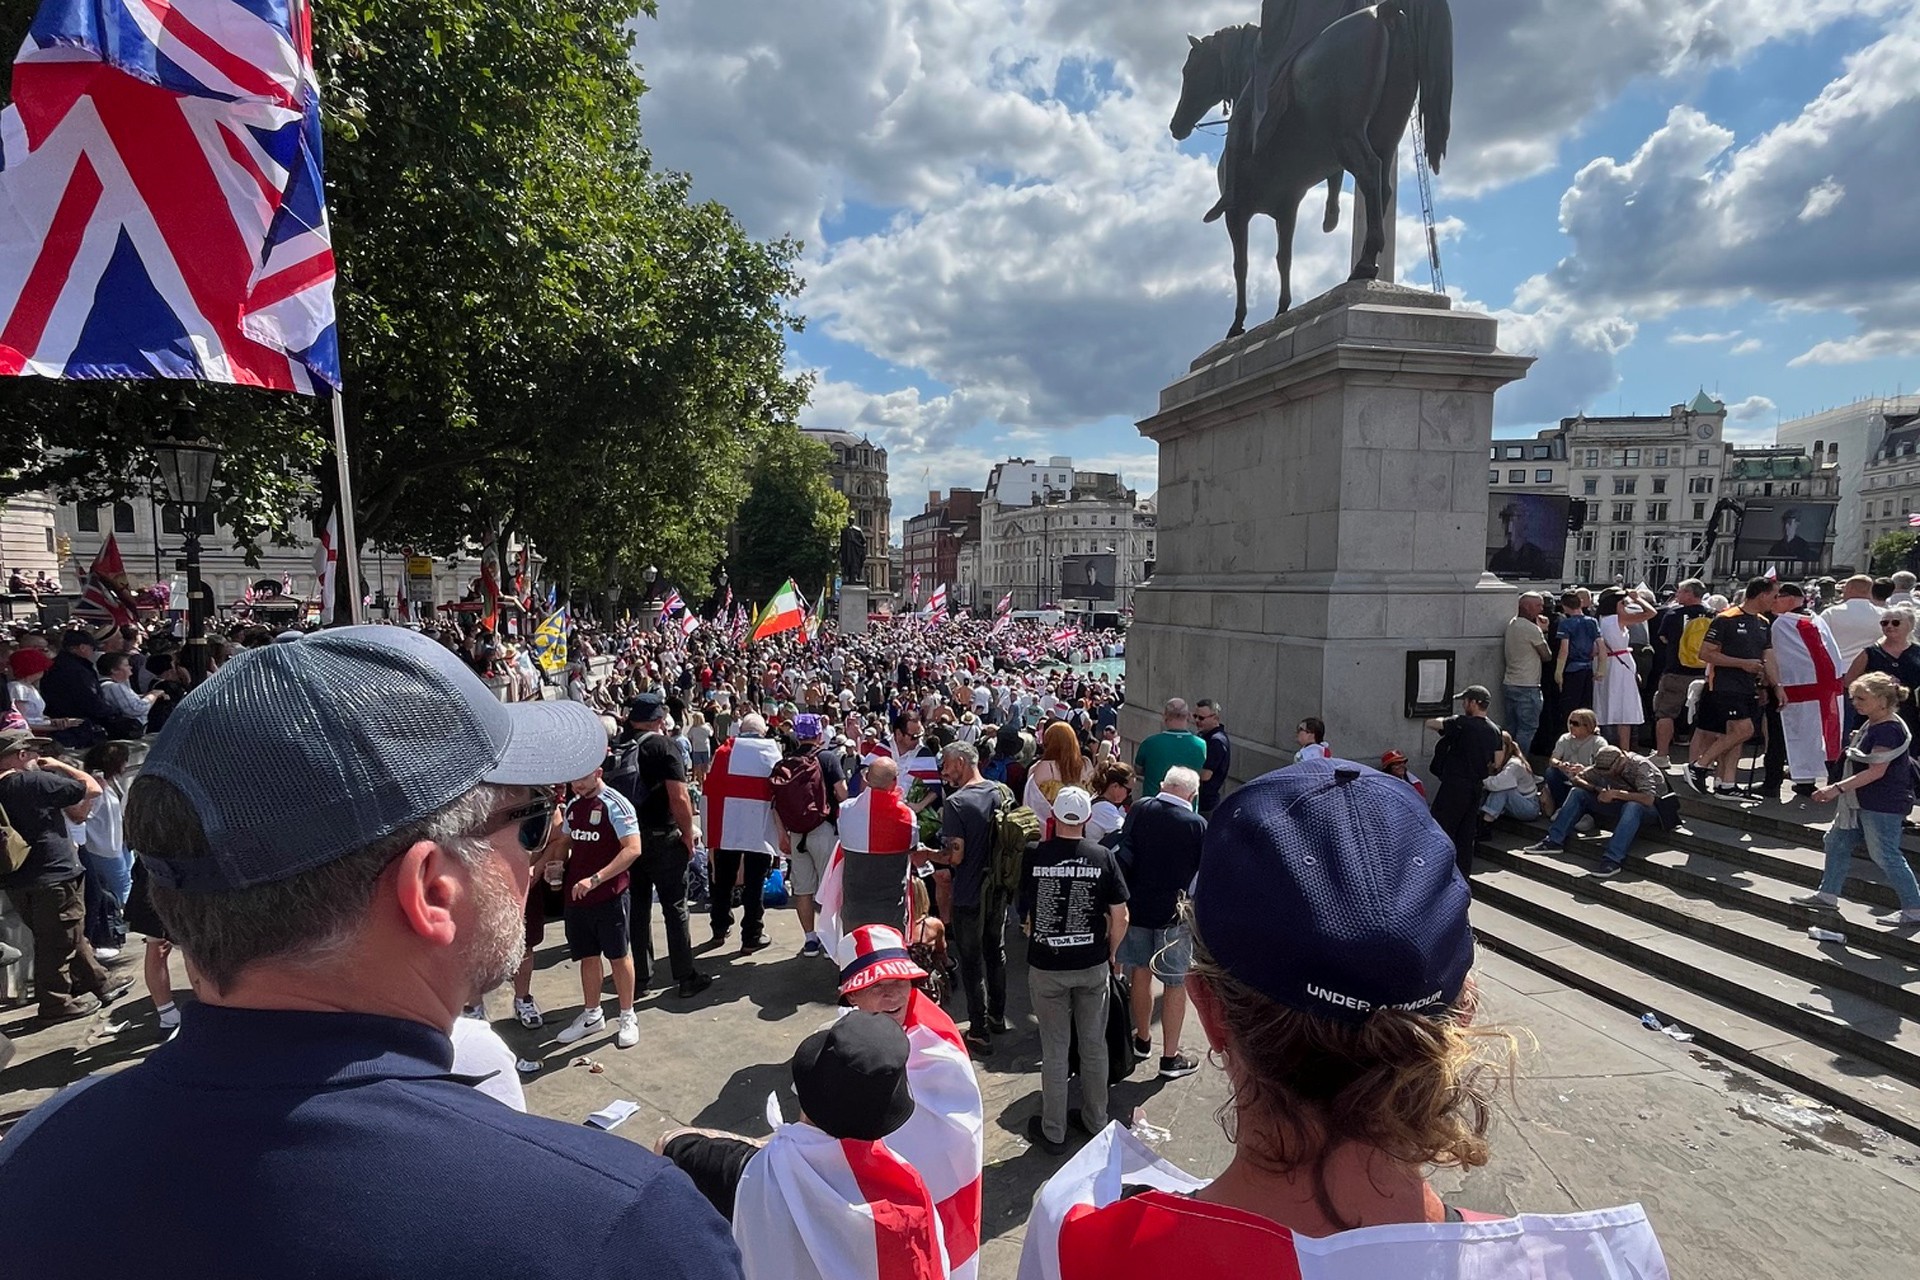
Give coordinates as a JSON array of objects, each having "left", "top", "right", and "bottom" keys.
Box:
[{"left": 733, "top": 1096, "right": 947, "bottom": 1280}]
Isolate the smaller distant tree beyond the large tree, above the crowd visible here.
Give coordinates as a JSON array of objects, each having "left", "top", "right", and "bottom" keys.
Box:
[{"left": 732, "top": 428, "right": 851, "bottom": 601}]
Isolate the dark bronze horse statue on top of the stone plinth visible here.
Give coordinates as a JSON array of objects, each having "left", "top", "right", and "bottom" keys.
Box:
[{"left": 1169, "top": 0, "right": 1453, "bottom": 338}]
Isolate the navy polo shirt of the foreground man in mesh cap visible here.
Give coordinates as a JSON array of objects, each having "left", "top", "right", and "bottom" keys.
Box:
[{"left": 0, "top": 1004, "right": 739, "bottom": 1280}]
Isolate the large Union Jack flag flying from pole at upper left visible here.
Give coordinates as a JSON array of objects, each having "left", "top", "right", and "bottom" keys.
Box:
[{"left": 0, "top": 0, "right": 340, "bottom": 395}]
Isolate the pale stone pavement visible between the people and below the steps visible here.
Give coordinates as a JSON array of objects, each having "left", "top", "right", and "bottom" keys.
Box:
[{"left": 0, "top": 912, "right": 1920, "bottom": 1280}]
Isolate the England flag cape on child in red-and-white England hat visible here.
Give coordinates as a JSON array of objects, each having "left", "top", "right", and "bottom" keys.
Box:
[{"left": 887, "top": 990, "right": 987, "bottom": 1280}]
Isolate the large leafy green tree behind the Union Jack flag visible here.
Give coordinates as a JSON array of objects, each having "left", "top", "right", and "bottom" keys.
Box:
[{"left": 0, "top": 0, "right": 806, "bottom": 591}]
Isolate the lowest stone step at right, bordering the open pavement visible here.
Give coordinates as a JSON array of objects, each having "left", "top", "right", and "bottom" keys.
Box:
[{"left": 1473, "top": 894, "right": 1920, "bottom": 1142}]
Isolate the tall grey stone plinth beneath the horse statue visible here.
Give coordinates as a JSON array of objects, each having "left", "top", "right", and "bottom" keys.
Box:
[{"left": 1121, "top": 284, "right": 1532, "bottom": 783}]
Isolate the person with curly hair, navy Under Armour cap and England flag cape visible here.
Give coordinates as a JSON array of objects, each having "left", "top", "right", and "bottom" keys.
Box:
[{"left": 1021, "top": 760, "right": 1667, "bottom": 1280}]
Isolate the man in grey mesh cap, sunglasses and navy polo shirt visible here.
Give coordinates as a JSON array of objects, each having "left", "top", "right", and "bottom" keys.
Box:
[{"left": 0, "top": 628, "right": 739, "bottom": 1280}]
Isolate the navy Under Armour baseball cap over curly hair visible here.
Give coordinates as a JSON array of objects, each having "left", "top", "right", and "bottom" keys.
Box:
[{"left": 1194, "top": 760, "right": 1473, "bottom": 1023}]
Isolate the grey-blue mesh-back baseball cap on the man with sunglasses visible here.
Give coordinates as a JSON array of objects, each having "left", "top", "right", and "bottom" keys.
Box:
[{"left": 129, "top": 626, "right": 607, "bottom": 892}]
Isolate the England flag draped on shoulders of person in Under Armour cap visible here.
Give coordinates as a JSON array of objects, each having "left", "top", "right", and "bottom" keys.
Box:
[{"left": 1020, "top": 1125, "right": 1667, "bottom": 1280}]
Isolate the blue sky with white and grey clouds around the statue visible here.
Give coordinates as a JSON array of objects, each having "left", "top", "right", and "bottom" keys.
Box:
[{"left": 636, "top": 0, "right": 1920, "bottom": 522}]
